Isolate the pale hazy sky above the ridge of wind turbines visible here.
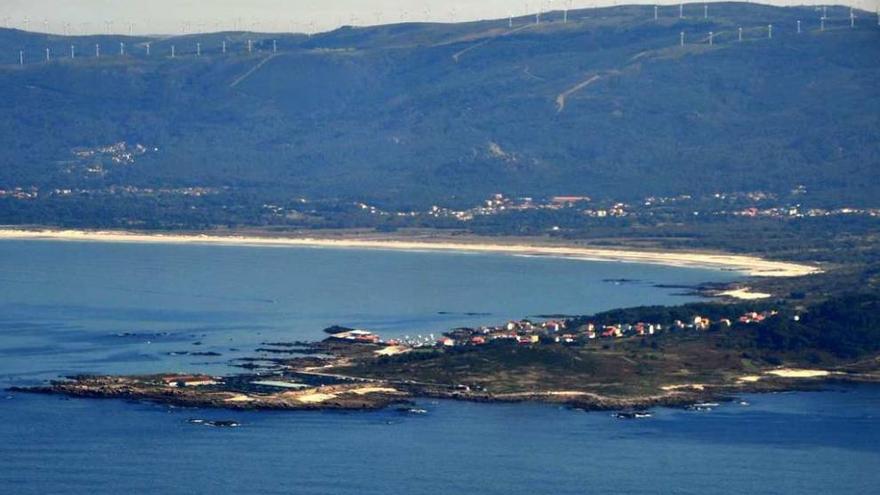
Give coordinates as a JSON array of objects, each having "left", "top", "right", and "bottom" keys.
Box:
[{"left": 0, "top": 0, "right": 880, "bottom": 35}]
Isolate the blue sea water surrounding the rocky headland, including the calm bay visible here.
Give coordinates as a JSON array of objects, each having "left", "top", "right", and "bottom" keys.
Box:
[{"left": 0, "top": 241, "right": 880, "bottom": 494}]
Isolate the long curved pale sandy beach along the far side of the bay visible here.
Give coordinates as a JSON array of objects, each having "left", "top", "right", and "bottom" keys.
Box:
[{"left": 0, "top": 229, "right": 821, "bottom": 277}]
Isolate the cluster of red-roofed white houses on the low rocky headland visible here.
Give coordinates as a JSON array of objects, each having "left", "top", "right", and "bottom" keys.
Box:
[{"left": 331, "top": 310, "right": 780, "bottom": 355}]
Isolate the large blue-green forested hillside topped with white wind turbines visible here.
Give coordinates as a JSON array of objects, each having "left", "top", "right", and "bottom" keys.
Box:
[{"left": 0, "top": 3, "right": 880, "bottom": 215}]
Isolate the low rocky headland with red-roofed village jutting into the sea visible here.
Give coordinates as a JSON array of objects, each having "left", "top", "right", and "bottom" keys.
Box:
[{"left": 17, "top": 294, "right": 880, "bottom": 411}]
